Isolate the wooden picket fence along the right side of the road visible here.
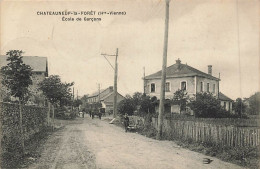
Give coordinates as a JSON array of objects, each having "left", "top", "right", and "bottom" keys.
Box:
[{"left": 152, "top": 118, "right": 260, "bottom": 147}]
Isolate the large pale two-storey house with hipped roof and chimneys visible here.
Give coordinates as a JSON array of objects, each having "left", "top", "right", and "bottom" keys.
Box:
[{"left": 143, "top": 59, "right": 232, "bottom": 114}]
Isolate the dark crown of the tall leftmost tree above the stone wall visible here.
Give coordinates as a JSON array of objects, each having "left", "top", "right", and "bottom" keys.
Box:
[{"left": 1, "top": 50, "right": 32, "bottom": 101}]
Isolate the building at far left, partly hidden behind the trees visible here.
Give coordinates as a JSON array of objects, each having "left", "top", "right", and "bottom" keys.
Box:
[{"left": 0, "top": 55, "right": 48, "bottom": 105}]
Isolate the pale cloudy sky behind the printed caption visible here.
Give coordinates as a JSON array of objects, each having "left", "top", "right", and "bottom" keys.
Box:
[{"left": 0, "top": 0, "right": 260, "bottom": 99}]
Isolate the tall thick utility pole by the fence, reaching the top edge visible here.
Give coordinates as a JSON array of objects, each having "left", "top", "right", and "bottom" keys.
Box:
[{"left": 156, "top": 0, "right": 170, "bottom": 140}]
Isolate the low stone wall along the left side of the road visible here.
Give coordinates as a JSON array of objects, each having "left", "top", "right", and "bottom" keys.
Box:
[{"left": 0, "top": 102, "right": 48, "bottom": 154}]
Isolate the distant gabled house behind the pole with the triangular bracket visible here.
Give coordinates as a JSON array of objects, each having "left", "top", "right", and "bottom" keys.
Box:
[{"left": 86, "top": 86, "right": 125, "bottom": 112}]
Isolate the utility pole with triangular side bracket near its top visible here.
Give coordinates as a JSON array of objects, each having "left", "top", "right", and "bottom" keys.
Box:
[{"left": 101, "top": 48, "right": 118, "bottom": 118}]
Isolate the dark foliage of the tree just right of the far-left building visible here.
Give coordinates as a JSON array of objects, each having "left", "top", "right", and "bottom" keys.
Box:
[{"left": 39, "top": 75, "right": 74, "bottom": 106}]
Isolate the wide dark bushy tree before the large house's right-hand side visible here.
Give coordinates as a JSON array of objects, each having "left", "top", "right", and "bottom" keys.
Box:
[{"left": 189, "top": 92, "right": 227, "bottom": 117}]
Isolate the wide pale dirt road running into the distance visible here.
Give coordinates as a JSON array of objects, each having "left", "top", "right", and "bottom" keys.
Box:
[{"left": 26, "top": 117, "right": 246, "bottom": 169}]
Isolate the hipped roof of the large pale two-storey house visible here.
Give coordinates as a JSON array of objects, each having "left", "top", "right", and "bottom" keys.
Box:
[{"left": 145, "top": 59, "right": 220, "bottom": 80}]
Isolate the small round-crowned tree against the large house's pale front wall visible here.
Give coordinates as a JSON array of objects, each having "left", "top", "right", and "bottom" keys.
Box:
[{"left": 173, "top": 89, "right": 189, "bottom": 112}]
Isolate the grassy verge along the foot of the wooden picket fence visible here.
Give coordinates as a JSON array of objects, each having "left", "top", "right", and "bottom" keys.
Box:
[{"left": 138, "top": 125, "right": 260, "bottom": 169}]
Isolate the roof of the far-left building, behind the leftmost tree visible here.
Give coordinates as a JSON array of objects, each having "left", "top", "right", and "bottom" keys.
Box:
[{"left": 0, "top": 55, "right": 47, "bottom": 72}]
